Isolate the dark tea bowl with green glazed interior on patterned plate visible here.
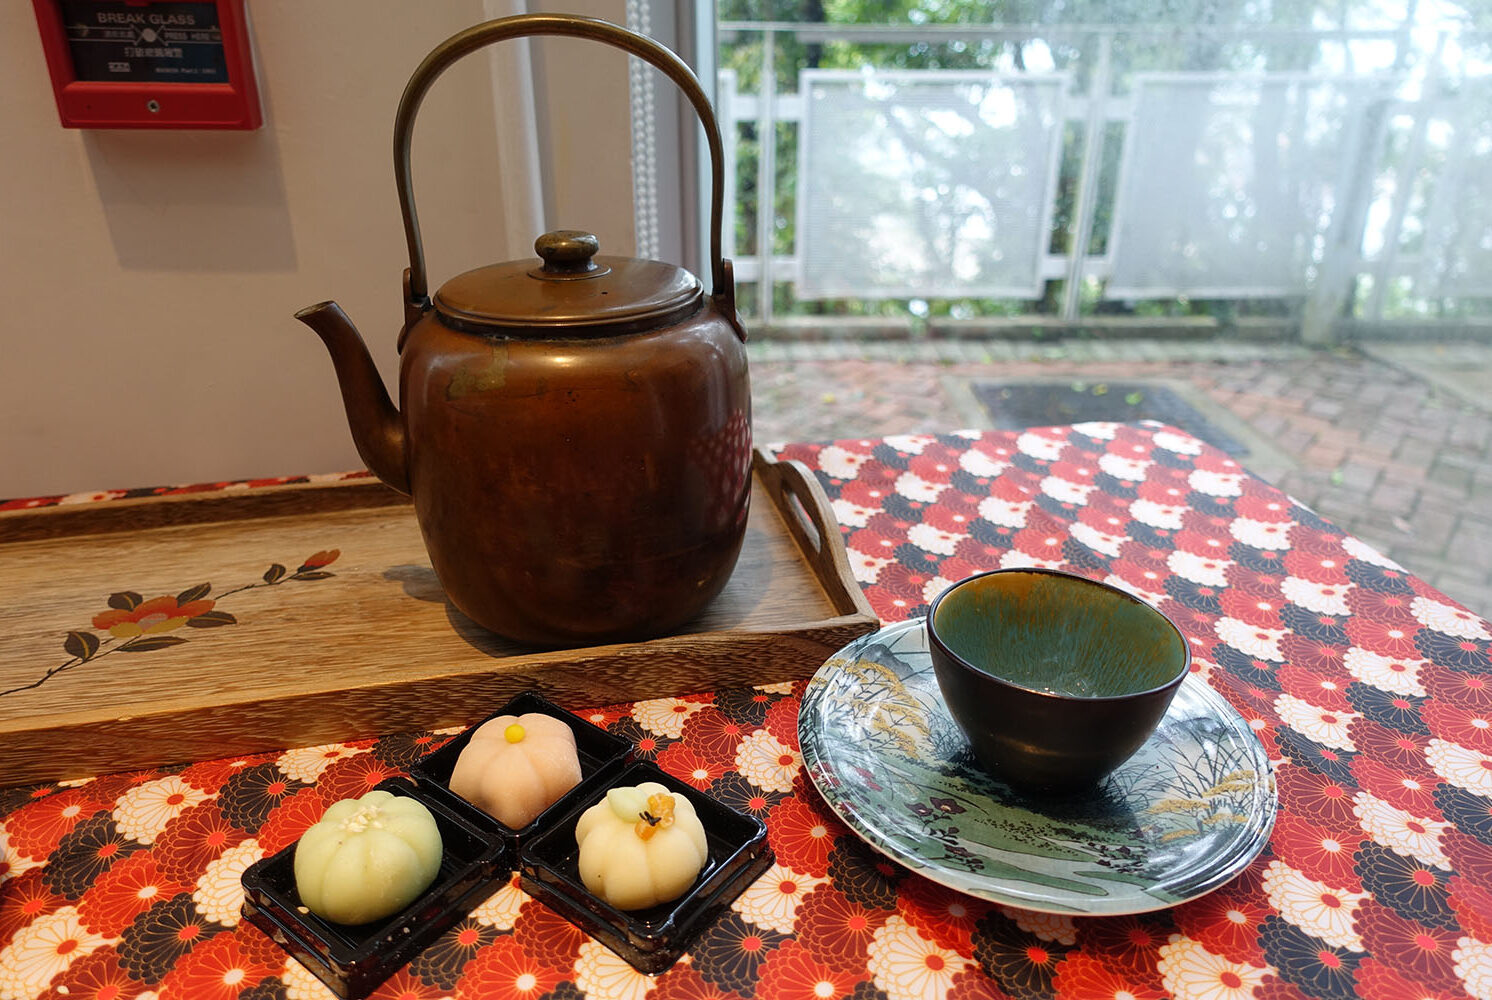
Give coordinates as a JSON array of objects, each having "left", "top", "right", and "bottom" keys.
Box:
[{"left": 927, "top": 569, "right": 1192, "bottom": 794}]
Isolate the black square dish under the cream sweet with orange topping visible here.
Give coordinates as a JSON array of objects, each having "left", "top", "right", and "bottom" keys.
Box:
[{"left": 519, "top": 763, "right": 773, "bottom": 975}]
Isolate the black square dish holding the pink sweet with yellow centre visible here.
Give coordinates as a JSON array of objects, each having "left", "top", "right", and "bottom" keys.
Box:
[{"left": 409, "top": 691, "right": 636, "bottom": 852}]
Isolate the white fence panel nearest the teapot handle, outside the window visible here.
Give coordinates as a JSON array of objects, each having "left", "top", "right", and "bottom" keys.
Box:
[{"left": 795, "top": 70, "right": 1068, "bottom": 299}]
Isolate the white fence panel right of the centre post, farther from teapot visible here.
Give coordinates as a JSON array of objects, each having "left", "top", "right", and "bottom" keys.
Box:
[{"left": 1106, "top": 73, "right": 1392, "bottom": 299}]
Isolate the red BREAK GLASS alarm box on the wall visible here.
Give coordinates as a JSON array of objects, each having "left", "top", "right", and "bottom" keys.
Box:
[{"left": 31, "top": 0, "right": 263, "bottom": 128}]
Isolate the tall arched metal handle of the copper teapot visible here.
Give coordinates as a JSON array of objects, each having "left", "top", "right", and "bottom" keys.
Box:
[{"left": 394, "top": 13, "right": 746, "bottom": 340}]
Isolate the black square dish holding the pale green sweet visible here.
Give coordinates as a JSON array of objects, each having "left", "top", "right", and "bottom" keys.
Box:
[{"left": 243, "top": 778, "right": 513, "bottom": 1000}]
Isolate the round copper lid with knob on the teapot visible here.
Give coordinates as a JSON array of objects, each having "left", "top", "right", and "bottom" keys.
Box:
[{"left": 433, "top": 230, "right": 704, "bottom": 337}]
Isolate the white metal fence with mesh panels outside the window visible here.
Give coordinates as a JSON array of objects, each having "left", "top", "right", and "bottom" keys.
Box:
[{"left": 719, "top": 22, "right": 1492, "bottom": 334}]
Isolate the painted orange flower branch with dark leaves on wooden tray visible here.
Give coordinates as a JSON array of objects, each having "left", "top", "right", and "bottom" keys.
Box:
[{"left": 0, "top": 549, "right": 342, "bottom": 697}]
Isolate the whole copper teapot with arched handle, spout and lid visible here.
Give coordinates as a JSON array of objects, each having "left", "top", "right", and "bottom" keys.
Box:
[{"left": 295, "top": 15, "right": 750, "bottom": 646}]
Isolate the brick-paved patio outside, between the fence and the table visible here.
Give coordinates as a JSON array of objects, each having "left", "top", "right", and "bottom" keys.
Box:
[{"left": 750, "top": 340, "right": 1492, "bottom": 618}]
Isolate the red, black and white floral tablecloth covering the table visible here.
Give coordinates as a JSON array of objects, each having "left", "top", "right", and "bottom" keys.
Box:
[{"left": 0, "top": 424, "right": 1492, "bottom": 1000}]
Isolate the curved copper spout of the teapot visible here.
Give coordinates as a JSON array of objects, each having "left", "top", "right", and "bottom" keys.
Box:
[{"left": 295, "top": 301, "right": 409, "bottom": 494}]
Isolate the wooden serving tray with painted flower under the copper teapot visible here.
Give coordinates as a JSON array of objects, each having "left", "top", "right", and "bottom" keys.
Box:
[{"left": 0, "top": 451, "right": 877, "bottom": 785}]
